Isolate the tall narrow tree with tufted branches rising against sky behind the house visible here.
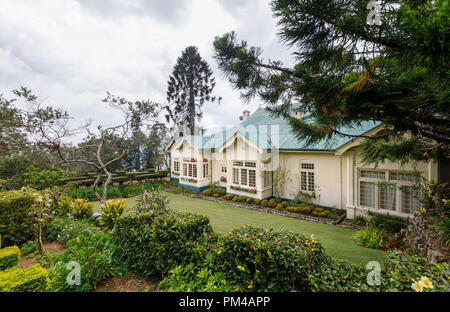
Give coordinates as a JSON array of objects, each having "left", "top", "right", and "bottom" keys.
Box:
[{"left": 166, "top": 46, "right": 221, "bottom": 134}]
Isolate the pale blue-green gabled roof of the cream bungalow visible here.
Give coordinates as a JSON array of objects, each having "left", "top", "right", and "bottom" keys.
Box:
[{"left": 168, "top": 108, "right": 380, "bottom": 151}]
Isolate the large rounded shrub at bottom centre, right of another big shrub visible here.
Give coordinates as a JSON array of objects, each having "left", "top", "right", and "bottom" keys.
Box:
[{"left": 212, "top": 226, "right": 325, "bottom": 291}]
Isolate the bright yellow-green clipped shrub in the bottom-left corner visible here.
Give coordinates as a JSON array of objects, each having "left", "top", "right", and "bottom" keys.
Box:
[{"left": 0, "top": 264, "right": 49, "bottom": 292}]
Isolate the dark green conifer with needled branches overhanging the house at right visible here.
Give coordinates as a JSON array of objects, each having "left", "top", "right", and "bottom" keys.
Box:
[{"left": 214, "top": 0, "right": 450, "bottom": 162}]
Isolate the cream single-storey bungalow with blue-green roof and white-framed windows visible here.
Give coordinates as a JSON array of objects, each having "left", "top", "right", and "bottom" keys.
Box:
[{"left": 167, "top": 108, "right": 439, "bottom": 218}]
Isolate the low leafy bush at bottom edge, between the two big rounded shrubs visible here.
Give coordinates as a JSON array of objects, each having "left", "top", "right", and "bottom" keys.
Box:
[{"left": 158, "top": 264, "right": 234, "bottom": 292}]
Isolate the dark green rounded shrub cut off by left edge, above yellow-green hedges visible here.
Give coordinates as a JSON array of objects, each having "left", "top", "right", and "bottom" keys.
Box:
[{"left": 0, "top": 190, "right": 34, "bottom": 246}]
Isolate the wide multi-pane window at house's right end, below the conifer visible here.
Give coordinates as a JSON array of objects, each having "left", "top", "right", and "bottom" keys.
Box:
[{"left": 359, "top": 169, "right": 418, "bottom": 214}]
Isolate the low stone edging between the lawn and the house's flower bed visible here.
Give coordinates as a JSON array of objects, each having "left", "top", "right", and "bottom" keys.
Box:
[{"left": 164, "top": 189, "right": 363, "bottom": 230}]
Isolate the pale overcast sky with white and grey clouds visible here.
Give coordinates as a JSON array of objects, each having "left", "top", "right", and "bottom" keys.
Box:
[{"left": 0, "top": 0, "right": 292, "bottom": 140}]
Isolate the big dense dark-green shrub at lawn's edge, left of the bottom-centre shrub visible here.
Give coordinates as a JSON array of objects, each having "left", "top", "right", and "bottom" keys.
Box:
[{"left": 115, "top": 212, "right": 212, "bottom": 277}]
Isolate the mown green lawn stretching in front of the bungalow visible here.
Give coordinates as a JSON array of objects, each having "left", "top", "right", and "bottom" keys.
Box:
[{"left": 95, "top": 193, "right": 386, "bottom": 265}]
